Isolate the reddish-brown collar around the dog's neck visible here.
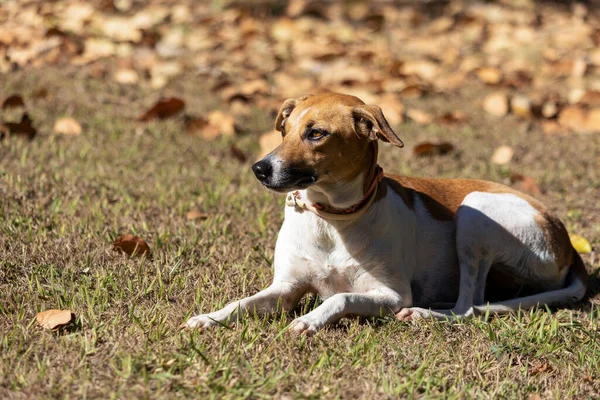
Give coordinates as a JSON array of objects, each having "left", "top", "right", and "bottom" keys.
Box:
[{"left": 285, "top": 165, "right": 383, "bottom": 220}]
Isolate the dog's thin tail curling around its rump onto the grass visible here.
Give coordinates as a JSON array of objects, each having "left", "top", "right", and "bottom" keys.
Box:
[{"left": 473, "top": 249, "right": 589, "bottom": 314}]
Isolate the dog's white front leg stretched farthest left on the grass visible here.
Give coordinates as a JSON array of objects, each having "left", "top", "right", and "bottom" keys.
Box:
[{"left": 184, "top": 281, "right": 306, "bottom": 329}]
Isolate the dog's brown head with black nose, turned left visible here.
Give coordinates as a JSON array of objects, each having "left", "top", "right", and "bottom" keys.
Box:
[{"left": 252, "top": 93, "right": 404, "bottom": 192}]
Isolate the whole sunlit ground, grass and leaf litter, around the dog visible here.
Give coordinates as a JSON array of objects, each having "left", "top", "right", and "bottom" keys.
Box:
[{"left": 0, "top": 0, "right": 600, "bottom": 400}]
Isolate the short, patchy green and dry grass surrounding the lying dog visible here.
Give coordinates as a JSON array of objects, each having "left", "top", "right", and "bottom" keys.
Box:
[{"left": 0, "top": 69, "right": 600, "bottom": 398}]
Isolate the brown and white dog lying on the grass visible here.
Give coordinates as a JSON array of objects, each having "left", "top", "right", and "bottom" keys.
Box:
[{"left": 185, "top": 93, "right": 587, "bottom": 334}]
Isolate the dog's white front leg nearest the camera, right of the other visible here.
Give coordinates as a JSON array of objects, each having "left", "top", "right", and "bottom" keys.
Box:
[{"left": 290, "top": 290, "right": 403, "bottom": 335}]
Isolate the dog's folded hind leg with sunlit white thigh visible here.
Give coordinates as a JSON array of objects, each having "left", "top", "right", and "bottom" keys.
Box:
[{"left": 398, "top": 192, "right": 587, "bottom": 319}]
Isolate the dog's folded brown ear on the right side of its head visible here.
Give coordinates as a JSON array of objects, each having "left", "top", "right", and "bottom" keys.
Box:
[{"left": 352, "top": 104, "right": 404, "bottom": 147}]
